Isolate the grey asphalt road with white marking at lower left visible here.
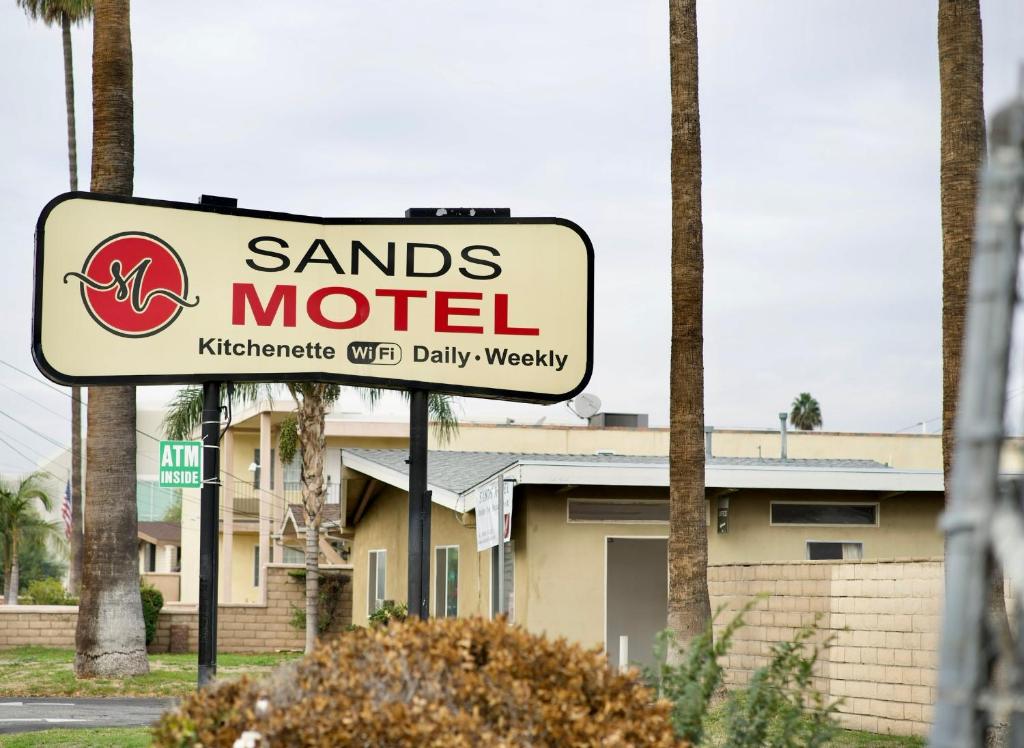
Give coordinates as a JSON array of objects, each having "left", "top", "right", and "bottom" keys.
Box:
[{"left": 0, "top": 697, "right": 177, "bottom": 735}]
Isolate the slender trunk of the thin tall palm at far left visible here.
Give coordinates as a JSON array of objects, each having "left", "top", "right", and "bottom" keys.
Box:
[{"left": 60, "top": 13, "right": 82, "bottom": 594}]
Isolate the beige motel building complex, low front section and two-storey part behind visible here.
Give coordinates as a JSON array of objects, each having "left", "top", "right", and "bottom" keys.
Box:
[{"left": 174, "top": 401, "right": 943, "bottom": 662}]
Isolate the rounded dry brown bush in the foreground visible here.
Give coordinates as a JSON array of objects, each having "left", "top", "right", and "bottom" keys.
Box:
[{"left": 155, "top": 618, "right": 679, "bottom": 748}]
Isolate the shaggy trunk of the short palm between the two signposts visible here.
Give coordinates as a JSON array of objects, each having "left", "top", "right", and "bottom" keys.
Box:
[{"left": 293, "top": 384, "right": 327, "bottom": 654}]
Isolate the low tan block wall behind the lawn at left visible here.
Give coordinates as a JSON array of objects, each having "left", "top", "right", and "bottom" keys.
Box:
[{"left": 0, "top": 564, "right": 352, "bottom": 653}]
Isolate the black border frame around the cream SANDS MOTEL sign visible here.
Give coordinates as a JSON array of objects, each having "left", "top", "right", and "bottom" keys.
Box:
[{"left": 32, "top": 191, "right": 594, "bottom": 404}]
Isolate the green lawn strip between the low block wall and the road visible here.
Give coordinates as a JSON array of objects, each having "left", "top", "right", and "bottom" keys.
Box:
[{"left": 0, "top": 647, "right": 301, "bottom": 696}]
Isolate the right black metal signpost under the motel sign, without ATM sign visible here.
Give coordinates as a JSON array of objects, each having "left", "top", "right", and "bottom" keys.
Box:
[{"left": 409, "top": 389, "right": 430, "bottom": 619}]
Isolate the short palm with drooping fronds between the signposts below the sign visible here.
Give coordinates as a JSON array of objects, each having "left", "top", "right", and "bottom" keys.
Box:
[{"left": 164, "top": 382, "right": 458, "bottom": 654}]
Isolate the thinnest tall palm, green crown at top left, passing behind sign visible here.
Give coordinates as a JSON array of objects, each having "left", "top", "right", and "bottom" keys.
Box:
[{"left": 16, "top": 0, "right": 92, "bottom": 594}]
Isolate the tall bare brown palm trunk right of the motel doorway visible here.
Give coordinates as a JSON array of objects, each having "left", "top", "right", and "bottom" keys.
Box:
[{"left": 668, "top": 0, "right": 711, "bottom": 652}]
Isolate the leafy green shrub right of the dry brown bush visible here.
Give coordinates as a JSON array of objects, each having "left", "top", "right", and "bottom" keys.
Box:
[{"left": 645, "top": 600, "right": 842, "bottom": 748}]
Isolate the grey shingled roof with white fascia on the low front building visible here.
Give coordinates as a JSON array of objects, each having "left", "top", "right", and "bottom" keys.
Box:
[{"left": 342, "top": 449, "right": 942, "bottom": 510}]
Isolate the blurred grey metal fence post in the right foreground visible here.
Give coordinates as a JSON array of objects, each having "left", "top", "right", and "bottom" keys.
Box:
[{"left": 931, "top": 96, "right": 1024, "bottom": 748}]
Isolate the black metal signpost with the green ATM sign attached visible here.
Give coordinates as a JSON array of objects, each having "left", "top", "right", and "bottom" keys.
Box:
[{"left": 199, "top": 382, "right": 220, "bottom": 688}]
